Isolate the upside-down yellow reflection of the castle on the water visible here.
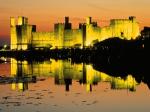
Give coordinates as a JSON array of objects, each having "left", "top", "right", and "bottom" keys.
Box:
[{"left": 11, "top": 59, "right": 138, "bottom": 92}]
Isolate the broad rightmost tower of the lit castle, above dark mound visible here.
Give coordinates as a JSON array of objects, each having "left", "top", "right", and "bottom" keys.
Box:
[{"left": 110, "top": 17, "right": 140, "bottom": 40}]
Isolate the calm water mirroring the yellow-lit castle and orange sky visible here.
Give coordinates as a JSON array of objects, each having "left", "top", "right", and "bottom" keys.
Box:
[{"left": 0, "top": 59, "right": 150, "bottom": 112}]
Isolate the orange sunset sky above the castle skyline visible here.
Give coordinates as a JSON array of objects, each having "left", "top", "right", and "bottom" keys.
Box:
[{"left": 0, "top": 0, "right": 150, "bottom": 45}]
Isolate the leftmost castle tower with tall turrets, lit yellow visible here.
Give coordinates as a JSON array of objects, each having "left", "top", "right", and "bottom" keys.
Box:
[{"left": 10, "top": 16, "right": 36, "bottom": 50}]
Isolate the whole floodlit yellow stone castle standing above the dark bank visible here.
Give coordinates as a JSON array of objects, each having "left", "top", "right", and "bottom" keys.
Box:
[{"left": 10, "top": 16, "right": 140, "bottom": 50}]
